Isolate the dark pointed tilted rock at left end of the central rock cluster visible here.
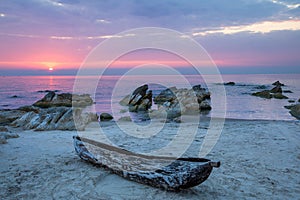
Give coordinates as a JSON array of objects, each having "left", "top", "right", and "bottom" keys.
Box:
[{"left": 128, "top": 85, "right": 152, "bottom": 112}]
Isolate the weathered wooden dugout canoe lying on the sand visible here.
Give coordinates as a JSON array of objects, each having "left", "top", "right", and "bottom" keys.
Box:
[{"left": 73, "top": 136, "right": 220, "bottom": 191}]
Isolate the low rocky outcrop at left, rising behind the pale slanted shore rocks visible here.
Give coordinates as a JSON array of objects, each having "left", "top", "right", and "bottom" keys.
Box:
[{"left": 33, "top": 91, "right": 93, "bottom": 108}]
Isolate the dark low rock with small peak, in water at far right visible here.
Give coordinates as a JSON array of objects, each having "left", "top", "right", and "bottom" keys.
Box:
[{"left": 252, "top": 81, "right": 288, "bottom": 99}]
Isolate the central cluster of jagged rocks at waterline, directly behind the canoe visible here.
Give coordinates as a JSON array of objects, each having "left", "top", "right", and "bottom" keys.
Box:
[{"left": 120, "top": 85, "right": 211, "bottom": 119}]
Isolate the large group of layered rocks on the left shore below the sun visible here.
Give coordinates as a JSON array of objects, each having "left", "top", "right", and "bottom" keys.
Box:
[{"left": 0, "top": 91, "right": 98, "bottom": 134}]
